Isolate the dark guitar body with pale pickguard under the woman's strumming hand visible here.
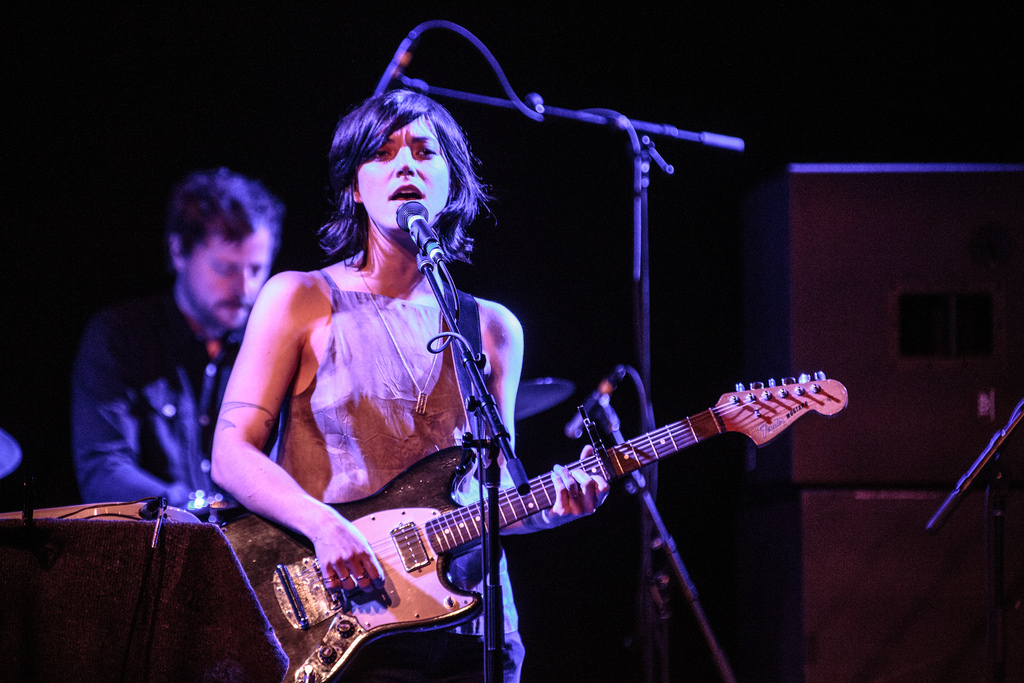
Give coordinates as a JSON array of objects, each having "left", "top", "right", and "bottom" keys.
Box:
[{"left": 223, "top": 447, "right": 481, "bottom": 681}]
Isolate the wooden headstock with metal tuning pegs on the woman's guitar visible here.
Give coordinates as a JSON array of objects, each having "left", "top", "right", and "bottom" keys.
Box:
[{"left": 712, "top": 373, "right": 847, "bottom": 445}]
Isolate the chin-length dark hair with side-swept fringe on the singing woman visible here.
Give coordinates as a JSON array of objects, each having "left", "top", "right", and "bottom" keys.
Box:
[{"left": 319, "top": 90, "right": 490, "bottom": 262}]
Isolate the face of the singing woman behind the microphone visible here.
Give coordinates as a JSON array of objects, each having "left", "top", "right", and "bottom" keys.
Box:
[{"left": 354, "top": 117, "right": 451, "bottom": 236}]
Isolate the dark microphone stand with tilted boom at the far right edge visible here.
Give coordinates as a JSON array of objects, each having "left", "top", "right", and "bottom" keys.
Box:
[{"left": 925, "top": 398, "right": 1024, "bottom": 683}]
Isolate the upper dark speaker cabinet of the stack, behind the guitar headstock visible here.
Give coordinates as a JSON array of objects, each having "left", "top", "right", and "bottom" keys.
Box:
[{"left": 744, "top": 165, "right": 1024, "bottom": 486}]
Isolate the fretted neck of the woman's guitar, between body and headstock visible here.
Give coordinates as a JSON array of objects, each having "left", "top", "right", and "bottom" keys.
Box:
[{"left": 426, "top": 410, "right": 725, "bottom": 554}]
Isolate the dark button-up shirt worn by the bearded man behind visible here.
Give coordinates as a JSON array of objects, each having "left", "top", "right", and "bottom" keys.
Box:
[{"left": 72, "top": 294, "right": 241, "bottom": 507}]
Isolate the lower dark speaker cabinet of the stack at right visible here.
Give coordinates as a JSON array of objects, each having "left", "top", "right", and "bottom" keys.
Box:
[{"left": 736, "top": 489, "right": 1024, "bottom": 683}]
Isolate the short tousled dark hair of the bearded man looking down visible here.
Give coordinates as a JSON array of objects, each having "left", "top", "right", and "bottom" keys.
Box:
[{"left": 166, "top": 168, "right": 285, "bottom": 256}]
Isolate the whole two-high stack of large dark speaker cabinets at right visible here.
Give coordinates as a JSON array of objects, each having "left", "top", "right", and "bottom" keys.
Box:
[{"left": 737, "top": 165, "right": 1024, "bottom": 683}]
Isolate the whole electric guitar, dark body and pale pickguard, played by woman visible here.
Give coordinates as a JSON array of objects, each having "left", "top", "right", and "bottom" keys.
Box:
[{"left": 223, "top": 373, "right": 847, "bottom": 682}]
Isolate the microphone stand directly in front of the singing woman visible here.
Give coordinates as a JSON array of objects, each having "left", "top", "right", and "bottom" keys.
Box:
[{"left": 417, "top": 253, "right": 529, "bottom": 682}]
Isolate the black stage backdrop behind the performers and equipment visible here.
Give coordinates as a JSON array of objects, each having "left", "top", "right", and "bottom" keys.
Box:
[{"left": 0, "top": 2, "right": 1024, "bottom": 681}]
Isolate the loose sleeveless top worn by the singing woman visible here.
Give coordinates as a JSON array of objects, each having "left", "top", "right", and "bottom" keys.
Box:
[{"left": 276, "top": 271, "right": 518, "bottom": 633}]
